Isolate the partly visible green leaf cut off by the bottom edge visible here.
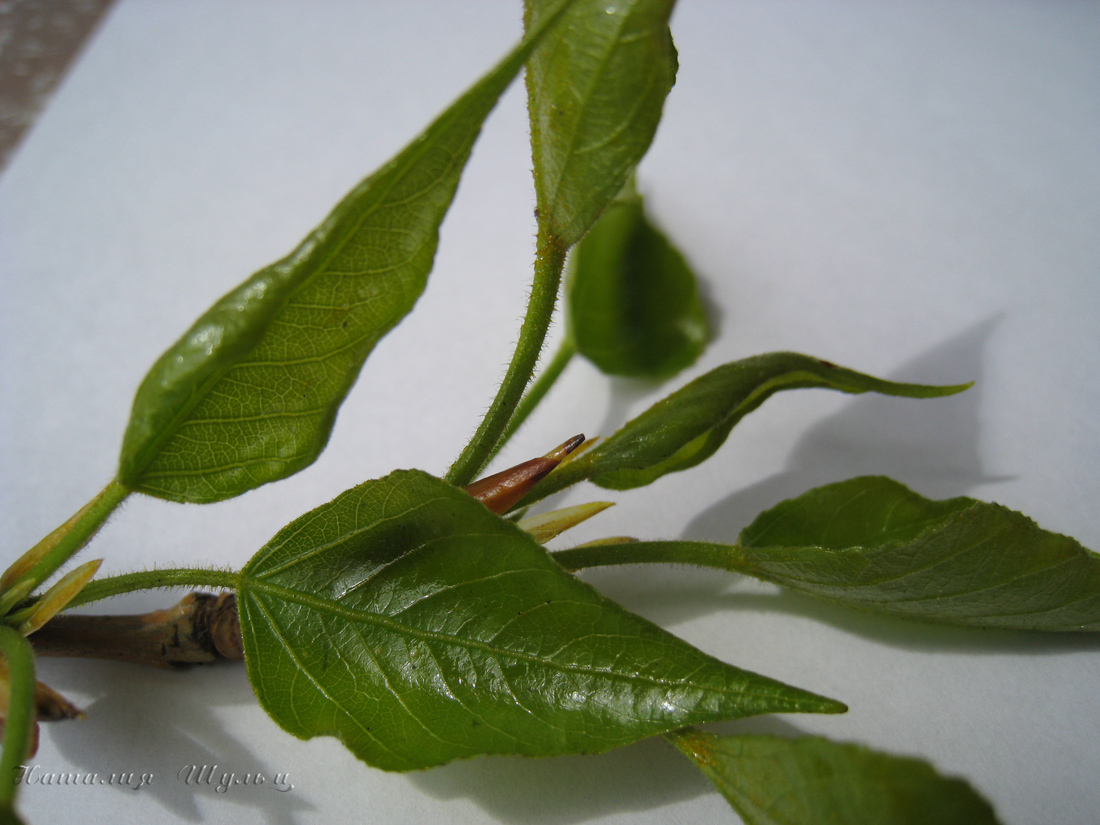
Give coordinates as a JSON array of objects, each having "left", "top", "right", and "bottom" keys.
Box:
[{"left": 669, "top": 730, "right": 997, "bottom": 825}]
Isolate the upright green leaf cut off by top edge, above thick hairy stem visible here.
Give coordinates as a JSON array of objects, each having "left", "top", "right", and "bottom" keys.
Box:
[{"left": 524, "top": 0, "right": 677, "bottom": 248}]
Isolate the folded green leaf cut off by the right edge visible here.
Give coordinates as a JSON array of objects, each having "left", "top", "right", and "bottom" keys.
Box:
[{"left": 738, "top": 476, "right": 1100, "bottom": 630}]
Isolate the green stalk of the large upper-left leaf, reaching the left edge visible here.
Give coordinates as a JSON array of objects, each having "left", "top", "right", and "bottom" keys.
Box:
[{"left": 0, "top": 479, "right": 131, "bottom": 616}]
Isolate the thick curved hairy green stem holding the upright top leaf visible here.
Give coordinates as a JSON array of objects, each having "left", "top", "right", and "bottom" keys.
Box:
[{"left": 446, "top": 229, "right": 565, "bottom": 487}]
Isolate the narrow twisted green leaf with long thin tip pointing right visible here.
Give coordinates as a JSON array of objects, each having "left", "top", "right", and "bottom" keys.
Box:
[{"left": 529, "top": 352, "right": 970, "bottom": 501}]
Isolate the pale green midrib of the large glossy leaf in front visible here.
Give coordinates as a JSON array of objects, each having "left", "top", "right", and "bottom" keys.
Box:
[{"left": 238, "top": 576, "right": 783, "bottom": 696}]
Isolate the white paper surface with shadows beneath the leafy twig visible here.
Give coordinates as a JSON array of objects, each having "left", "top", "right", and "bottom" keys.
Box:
[{"left": 0, "top": 0, "right": 1100, "bottom": 825}]
